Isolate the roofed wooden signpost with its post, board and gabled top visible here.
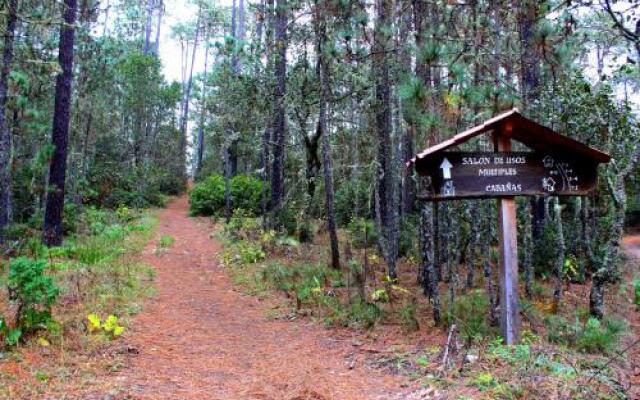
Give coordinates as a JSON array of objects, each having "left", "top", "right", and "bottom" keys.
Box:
[{"left": 408, "top": 109, "right": 610, "bottom": 344}]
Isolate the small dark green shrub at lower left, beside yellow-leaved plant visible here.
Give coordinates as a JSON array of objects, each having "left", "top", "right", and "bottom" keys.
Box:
[{"left": 7, "top": 257, "right": 59, "bottom": 333}]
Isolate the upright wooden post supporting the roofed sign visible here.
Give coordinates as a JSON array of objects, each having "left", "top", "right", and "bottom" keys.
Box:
[{"left": 494, "top": 124, "right": 520, "bottom": 345}]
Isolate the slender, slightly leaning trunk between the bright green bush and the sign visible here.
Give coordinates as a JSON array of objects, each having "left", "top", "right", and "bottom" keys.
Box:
[{"left": 315, "top": 1, "right": 340, "bottom": 269}]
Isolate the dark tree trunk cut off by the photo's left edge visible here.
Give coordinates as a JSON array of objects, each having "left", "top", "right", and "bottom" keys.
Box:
[{"left": 0, "top": 0, "right": 18, "bottom": 243}]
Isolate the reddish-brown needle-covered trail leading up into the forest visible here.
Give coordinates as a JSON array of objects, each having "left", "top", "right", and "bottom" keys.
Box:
[{"left": 107, "top": 196, "right": 401, "bottom": 400}]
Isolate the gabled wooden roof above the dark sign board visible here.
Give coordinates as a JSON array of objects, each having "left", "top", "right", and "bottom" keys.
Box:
[{"left": 407, "top": 108, "right": 611, "bottom": 166}]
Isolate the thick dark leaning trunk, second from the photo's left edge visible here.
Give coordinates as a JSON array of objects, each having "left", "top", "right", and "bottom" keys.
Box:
[{"left": 42, "top": 0, "right": 77, "bottom": 246}]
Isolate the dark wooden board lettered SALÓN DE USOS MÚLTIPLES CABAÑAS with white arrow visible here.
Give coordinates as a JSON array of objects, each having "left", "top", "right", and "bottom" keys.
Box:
[{"left": 418, "top": 152, "right": 597, "bottom": 200}]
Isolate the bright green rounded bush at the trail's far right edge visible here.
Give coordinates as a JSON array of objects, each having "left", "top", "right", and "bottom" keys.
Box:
[{"left": 189, "top": 174, "right": 264, "bottom": 216}]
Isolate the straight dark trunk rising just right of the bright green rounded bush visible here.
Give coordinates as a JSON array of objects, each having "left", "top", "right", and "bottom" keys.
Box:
[{"left": 271, "top": 0, "right": 287, "bottom": 219}]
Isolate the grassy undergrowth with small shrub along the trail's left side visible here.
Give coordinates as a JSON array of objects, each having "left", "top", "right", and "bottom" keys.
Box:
[{"left": 0, "top": 208, "right": 156, "bottom": 346}]
